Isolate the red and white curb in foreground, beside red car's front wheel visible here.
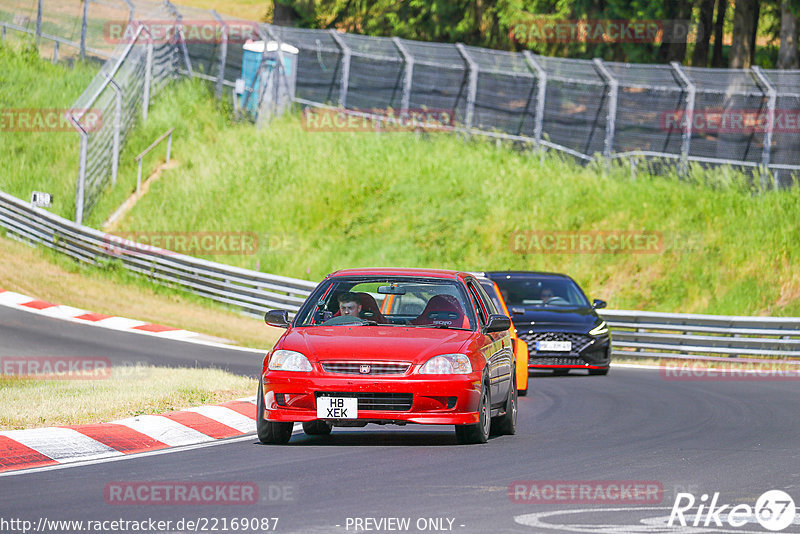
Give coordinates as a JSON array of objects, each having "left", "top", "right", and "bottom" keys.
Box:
[{"left": 0, "top": 397, "right": 256, "bottom": 473}]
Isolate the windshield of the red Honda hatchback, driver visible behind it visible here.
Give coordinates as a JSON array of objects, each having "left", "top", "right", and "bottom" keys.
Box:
[{"left": 295, "top": 277, "right": 476, "bottom": 330}]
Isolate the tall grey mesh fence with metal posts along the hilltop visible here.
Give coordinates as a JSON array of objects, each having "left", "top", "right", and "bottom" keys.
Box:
[{"left": 0, "top": 0, "right": 800, "bottom": 222}]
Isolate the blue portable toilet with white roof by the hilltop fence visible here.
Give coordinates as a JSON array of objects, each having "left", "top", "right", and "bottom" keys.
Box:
[{"left": 241, "top": 41, "right": 300, "bottom": 113}]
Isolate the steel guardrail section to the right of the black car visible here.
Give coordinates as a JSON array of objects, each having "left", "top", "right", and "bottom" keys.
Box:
[{"left": 601, "top": 310, "right": 800, "bottom": 364}]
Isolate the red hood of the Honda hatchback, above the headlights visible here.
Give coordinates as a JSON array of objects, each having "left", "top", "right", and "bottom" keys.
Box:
[{"left": 278, "top": 326, "right": 477, "bottom": 363}]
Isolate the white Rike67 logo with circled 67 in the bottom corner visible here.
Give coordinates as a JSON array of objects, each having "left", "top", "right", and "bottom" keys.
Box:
[{"left": 667, "top": 490, "right": 796, "bottom": 532}]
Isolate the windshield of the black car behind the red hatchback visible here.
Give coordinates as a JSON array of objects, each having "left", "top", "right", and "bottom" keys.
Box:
[{"left": 495, "top": 277, "right": 590, "bottom": 308}]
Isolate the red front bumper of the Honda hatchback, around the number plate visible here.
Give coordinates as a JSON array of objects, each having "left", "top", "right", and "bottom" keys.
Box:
[{"left": 263, "top": 371, "right": 481, "bottom": 425}]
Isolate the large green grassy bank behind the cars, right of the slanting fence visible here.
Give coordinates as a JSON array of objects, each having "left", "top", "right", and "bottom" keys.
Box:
[{"left": 86, "top": 83, "right": 800, "bottom": 315}]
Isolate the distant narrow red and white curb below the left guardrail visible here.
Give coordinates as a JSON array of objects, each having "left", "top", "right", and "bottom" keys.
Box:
[{"left": 0, "top": 288, "right": 264, "bottom": 353}]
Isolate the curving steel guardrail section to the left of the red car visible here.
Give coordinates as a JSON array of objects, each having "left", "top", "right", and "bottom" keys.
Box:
[{"left": 0, "top": 191, "right": 317, "bottom": 316}]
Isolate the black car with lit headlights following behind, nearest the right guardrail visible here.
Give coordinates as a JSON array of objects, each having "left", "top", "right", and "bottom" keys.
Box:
[{"left": 485, "top": 271, "right": 611, "bottom": 375}]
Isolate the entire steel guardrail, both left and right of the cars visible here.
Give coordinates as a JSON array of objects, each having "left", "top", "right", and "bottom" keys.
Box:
[{"left": 0, "top": 191, "right": 800, "bottom": 363}]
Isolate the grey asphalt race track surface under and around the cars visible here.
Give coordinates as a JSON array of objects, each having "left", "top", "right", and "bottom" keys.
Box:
[{"left": 0, "top": 308, "right": 800, "bottom": 533}]
